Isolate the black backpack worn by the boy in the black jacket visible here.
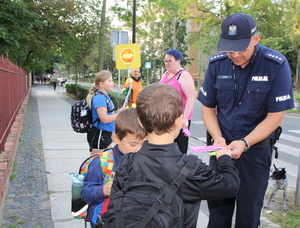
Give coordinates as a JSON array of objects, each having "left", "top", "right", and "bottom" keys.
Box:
[{"left": 97, "top": 153, "right": 198, "bottom": 228}]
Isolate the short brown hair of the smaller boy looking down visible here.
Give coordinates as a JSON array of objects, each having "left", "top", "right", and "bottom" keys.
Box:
[{"left": 115, "top": 108, "right": 147, "bottom": 140}]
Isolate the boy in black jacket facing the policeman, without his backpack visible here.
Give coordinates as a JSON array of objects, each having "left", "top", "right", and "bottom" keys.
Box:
[{"left": 110, "top": 83, "right": 240, "bottom": 228}]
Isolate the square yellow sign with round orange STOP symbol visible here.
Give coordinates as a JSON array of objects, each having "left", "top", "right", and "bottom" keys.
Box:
[{"left": 115, "top": 44, "right": 141, "bottom": 70}]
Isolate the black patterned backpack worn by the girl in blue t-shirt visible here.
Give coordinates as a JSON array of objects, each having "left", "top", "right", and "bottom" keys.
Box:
[{"left": 71, "top": 91, "right": 114, "bottom": 133}]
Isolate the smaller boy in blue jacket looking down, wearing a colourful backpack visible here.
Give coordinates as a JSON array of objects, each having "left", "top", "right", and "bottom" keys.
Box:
[{"left": 81, "top": 109, "right": 147, "bottom": 228}]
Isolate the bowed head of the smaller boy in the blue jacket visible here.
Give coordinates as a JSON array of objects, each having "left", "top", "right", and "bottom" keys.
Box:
[{"left": 113, "top": 108, "right": 147, "bottom": 154}]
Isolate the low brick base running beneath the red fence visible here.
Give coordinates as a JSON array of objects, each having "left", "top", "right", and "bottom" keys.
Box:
[{"left": 0, "top": 89, "right": 31, "bottom": 224}]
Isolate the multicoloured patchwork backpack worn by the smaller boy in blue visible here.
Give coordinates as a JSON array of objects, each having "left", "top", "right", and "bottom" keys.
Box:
[{"left": 71, "top": 148, "right": 114, "bottom": 222}]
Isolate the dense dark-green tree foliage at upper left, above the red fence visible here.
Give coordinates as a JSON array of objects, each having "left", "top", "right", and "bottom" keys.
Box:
[{"left": 0, "top": 0, "right": 113, "bottom": 74}]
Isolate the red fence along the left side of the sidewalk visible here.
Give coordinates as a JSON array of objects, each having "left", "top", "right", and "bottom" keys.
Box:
[{"left": 0, "top": 56, "right": 29, "bottom": 153}]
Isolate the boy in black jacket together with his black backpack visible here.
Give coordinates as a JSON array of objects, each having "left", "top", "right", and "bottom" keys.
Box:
[{"left": 102, "top": 83, "right": 239, "bottom": 228}]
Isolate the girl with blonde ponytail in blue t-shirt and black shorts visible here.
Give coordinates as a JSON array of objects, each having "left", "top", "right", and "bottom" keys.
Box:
[{"left": 86, "top": 70, "right": 125, "bottom": 155}]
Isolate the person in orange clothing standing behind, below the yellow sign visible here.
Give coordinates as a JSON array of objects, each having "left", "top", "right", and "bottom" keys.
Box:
[{"left": 122, "top": 69, "right": 143, "bottom": 108}]
